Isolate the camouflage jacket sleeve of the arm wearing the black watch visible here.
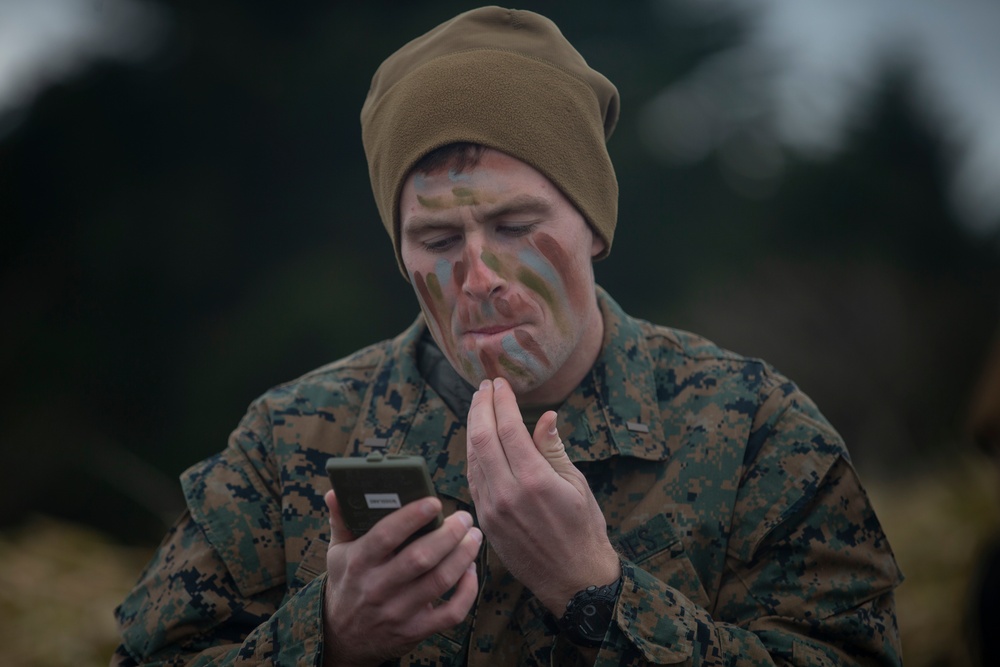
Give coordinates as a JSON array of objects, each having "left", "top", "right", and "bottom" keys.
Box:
[{"left": 596, "top": 387, "right": 902, "bottom": 667}]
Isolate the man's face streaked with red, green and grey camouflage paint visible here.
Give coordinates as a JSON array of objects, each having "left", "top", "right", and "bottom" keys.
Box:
[{"left": 399, "top": 150, "right": 604, "bottom": 405}]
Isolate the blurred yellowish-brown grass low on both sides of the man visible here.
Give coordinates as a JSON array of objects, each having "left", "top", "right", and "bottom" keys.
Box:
[{"left": 0, "top": 456, "right": 1000, "bottom": 667}]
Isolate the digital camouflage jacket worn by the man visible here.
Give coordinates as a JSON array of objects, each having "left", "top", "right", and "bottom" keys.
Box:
[{"left": 114, "top": 292, "right": 901, "bottom": 667}]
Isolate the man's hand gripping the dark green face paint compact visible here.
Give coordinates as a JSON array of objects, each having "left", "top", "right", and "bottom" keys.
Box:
[{"left": 323, "top": 491, "right": 483, "bottom": 667}]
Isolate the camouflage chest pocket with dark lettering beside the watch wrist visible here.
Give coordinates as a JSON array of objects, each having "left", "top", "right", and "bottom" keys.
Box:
[{"left": 612, "top": 514, "right": 711, "bottom": 609}]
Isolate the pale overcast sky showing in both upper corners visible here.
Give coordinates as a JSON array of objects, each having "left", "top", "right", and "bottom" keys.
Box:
[{"left": 0, "top": 0, "right": 1000, "bottom": 230}]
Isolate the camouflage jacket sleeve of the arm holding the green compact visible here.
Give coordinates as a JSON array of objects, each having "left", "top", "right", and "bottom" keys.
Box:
[{"left": 112, "top": 400, "right": 325, "bottom": 665}]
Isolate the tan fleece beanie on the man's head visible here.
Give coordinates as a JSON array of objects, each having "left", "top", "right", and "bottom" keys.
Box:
[{"left": 361, "top": 7, "right": 618, "bottom": 275}]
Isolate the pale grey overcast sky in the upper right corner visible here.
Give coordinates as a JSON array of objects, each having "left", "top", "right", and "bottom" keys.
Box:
[{"left": 644, "top": 0, "right": 1000, "bottom": 231}]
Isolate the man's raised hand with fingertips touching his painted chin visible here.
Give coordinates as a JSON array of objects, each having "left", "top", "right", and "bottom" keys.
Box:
[{"left": 468, "top": 379, "right": 621, "bottom": 616}]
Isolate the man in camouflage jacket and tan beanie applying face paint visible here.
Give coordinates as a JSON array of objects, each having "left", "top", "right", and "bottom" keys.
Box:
[{"left": 115, "top": 7, "right": 900, "bottom": 665}]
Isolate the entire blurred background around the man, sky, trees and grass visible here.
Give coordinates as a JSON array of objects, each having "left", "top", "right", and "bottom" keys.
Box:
[{"left": 0, "top": 0, "right": 1000, "bottom": 665}]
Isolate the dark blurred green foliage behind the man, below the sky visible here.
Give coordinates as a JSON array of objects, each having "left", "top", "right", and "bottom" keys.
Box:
[{"left": 0, "top": 0, "right": 1000, "bottom": 544}]
